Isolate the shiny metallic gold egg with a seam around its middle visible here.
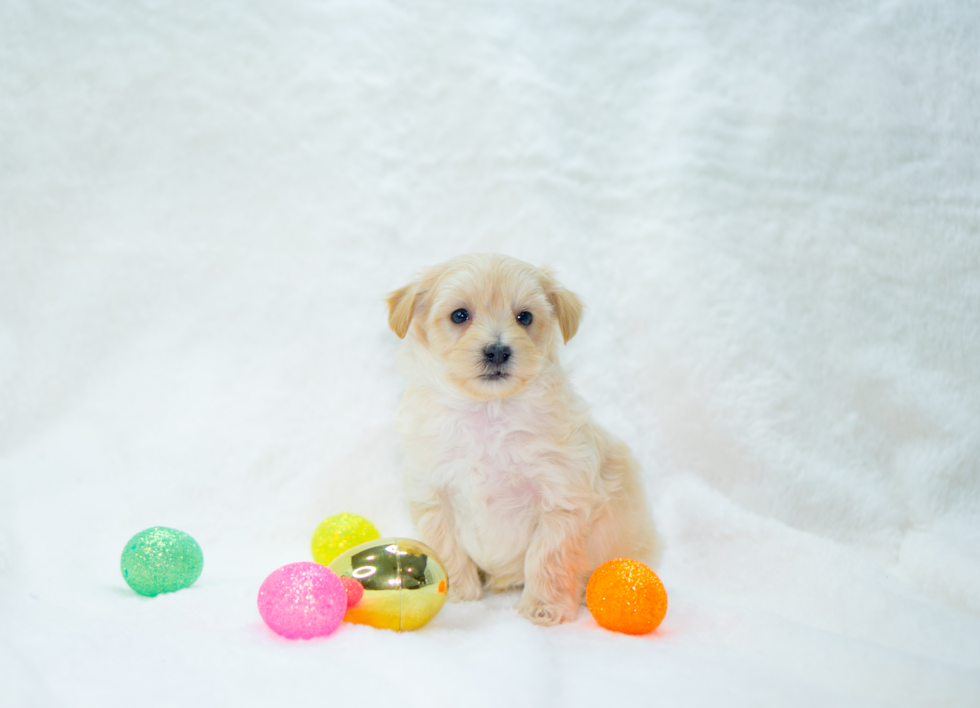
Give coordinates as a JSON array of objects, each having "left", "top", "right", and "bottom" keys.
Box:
[{"left": 328, "top": 538, "right": 449, "bottom": 632}]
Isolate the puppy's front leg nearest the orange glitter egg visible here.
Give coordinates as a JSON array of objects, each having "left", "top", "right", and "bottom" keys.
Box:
[{"left": 516, "top": 509, "right": 588, "bottom": 625}]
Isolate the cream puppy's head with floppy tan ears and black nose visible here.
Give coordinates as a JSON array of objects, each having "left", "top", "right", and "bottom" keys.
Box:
[{"left": 388, "top": 255, "right": 582, "bottom": 400}]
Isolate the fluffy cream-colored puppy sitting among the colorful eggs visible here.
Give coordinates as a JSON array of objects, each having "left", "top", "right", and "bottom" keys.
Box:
[{"left": 388, "top": 255, "right": 657, "bottom": 624}]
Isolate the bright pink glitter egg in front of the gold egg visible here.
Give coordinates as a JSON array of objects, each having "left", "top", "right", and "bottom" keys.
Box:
[{"left": 258, "top": 562, "right": 347, "bottom": 639}]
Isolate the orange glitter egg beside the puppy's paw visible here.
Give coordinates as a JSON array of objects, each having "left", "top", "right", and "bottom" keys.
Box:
[{"left": 585, "top": 558, "right": 667, "bottom": 634}]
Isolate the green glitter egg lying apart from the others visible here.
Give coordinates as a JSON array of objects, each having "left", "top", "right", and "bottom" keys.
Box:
[{"left": 120, "top": 526, "right": 204, "bottom": 597}]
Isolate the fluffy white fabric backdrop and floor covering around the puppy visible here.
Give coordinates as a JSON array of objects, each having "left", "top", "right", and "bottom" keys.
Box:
[{"left": 0, "top": 0, "right": 980, "bottom": 708}]
